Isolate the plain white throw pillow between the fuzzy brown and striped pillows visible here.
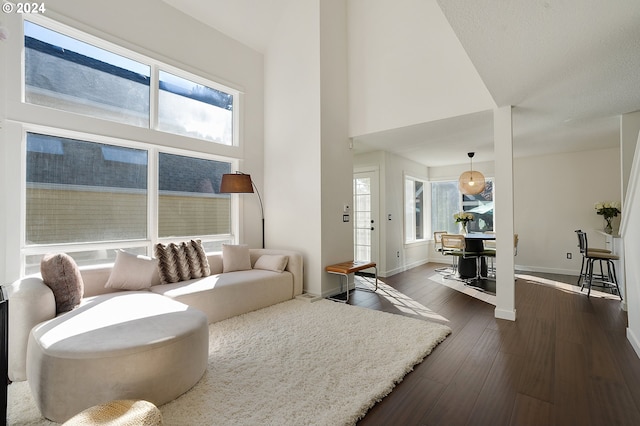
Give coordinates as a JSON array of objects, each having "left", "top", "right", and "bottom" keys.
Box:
[{"left": 105, "top": 250, "right": 160, "bottom": 290}]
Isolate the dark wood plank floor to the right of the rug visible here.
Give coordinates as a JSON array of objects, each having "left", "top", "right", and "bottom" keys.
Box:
[{"left": 350, "top": 264, "right": 640, "bottom": 426}]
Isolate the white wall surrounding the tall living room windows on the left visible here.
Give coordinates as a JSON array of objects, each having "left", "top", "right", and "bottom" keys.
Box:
[{"left": 0, "top": 0, "right": 268, "bottom": 281}]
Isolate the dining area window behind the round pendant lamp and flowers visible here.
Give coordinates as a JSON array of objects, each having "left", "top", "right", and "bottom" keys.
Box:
[{"left": 431, "top": 179, "right": 493, "bottom": 234}]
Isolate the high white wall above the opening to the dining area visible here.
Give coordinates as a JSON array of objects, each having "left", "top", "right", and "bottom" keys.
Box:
[{"left": 348, "top": 0, "right": 495, "bottom": 136}]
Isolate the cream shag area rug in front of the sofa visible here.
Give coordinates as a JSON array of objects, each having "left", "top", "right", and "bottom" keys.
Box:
[{"left": 9, "top": 300, "right": 451, "bottom": 426}]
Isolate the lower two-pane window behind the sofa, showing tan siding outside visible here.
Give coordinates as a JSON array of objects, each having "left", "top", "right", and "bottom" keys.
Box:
[{"left": 24, "top": 132, "right": 238, "bottom": 273}]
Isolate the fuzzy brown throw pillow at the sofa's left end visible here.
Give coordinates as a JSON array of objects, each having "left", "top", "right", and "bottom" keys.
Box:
[{"left": 40, "top": 253, "right": 84, "bottom": 314}]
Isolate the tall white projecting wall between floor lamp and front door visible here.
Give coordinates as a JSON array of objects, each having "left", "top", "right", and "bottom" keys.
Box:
[{"left": 265, "top": 0, "right": 353, "bottom": 295}]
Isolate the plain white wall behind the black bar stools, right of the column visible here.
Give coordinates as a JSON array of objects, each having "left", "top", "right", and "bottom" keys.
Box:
[{"left": 514, "top": 149, "right": 625, "bottom": 275}]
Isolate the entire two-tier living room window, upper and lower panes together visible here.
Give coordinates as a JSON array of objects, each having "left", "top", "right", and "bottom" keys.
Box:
[{"left": 20, "top": 15, "right": 239, "bottom": 273}]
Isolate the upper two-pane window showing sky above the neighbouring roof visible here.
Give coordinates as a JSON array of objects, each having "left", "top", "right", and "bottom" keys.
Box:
[{"left": 24, "top": 20, "right": 237, "bottom": 145}]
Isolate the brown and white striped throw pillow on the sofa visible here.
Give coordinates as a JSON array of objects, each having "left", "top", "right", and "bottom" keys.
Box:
[{"left": 155, "top": 240, "right": 211, "bottom": 284}]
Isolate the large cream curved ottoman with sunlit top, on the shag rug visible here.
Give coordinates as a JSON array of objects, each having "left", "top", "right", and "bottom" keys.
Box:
[{"left": 27, "top": 291, "right": 209, "bottom": 423}]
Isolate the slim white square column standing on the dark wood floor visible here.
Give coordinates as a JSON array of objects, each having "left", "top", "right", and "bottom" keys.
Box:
[{"left": 493, "top": 105, "right": 516, "bottom": 321}]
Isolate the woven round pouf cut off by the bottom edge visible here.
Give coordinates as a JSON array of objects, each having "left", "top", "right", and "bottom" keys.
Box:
[{"left": 62, "top": 399, "right": 162, "bottom": 426}]
